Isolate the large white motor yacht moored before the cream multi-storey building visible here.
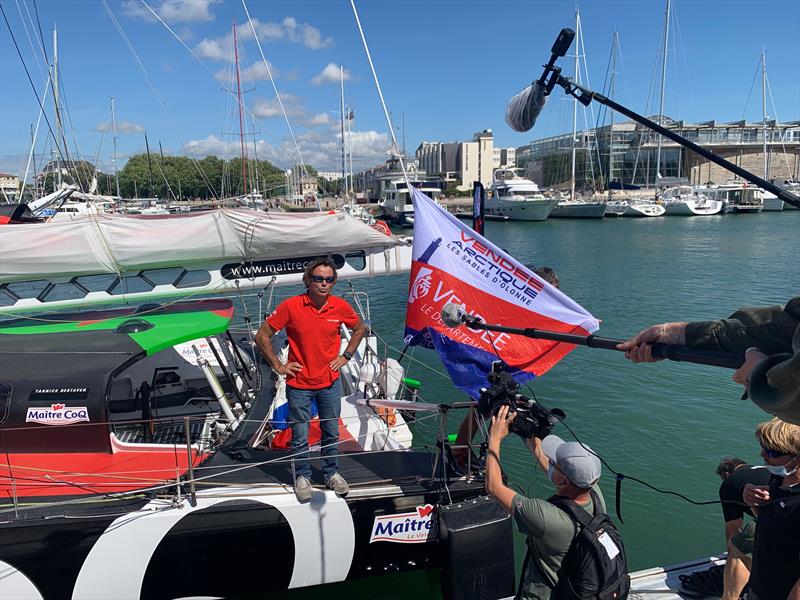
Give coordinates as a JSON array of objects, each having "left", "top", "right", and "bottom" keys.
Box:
[{"left": 484, "top": 168, "right": 558, "bottom": 221}]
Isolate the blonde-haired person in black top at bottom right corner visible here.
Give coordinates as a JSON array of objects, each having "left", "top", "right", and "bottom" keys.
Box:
[{"left": 742, "top": 417, "right": 800, "bottom": 600}]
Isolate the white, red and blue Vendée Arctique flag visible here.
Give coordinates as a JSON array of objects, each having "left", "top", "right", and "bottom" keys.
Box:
[{"left": 405, "top": 187, "right": 599, "bottom": 398}]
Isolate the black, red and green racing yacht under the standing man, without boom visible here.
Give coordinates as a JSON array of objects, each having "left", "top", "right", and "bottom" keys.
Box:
[{"left": 0, "top": 299, "right": 494, "bottom": 599}]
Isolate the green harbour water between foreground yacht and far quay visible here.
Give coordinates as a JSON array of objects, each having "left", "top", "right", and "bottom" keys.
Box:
[{"left": 260, "top": 211, "right": 800, "bottom": 597}]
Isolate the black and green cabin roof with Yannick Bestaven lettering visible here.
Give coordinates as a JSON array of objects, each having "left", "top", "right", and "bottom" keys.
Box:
[{"left": 0, "top": 299, "right": 233, "bottom": 453}]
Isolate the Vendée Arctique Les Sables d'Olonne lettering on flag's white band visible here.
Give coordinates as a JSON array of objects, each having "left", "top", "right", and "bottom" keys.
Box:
[{"left": 447, "top": 231, "right": 544, "bottom": 306}]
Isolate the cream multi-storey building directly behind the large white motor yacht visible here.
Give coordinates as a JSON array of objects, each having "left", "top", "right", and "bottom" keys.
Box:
[{"left": 415, "top": 129, "right": 516, "bottom": 191}]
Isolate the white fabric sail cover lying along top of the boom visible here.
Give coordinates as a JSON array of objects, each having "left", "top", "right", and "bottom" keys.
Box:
[{"left": 0, "top": 209, "right": 402, "bottom": 284}]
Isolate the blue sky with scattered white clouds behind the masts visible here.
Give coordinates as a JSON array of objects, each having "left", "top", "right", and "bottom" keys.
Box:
[{"left": 0, "top": 0, "right": 800, "bottom": 176}]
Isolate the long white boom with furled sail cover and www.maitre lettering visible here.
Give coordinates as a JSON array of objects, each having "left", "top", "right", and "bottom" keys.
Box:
[{"left": 0, "top": 209, "right": 411, "bottom": 314}]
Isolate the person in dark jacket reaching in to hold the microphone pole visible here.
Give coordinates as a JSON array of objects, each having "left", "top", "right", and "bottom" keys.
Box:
[{"left": 617, "top": 296, "right": 800, "bottom": 425}]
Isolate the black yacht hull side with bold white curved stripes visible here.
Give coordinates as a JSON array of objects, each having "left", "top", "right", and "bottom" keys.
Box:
[{"left": 0, "top": 478, "right": 483, "bottom": 600}]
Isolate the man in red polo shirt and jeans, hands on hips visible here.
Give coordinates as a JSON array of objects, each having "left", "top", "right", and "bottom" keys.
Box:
[{"left": 256, "top": 258, "right": 366, "bottom": 502}]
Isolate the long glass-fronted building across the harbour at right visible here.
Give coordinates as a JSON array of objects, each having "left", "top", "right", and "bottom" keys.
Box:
[{"left": 516, "top": 117, "right": 800, "bottom": 190}]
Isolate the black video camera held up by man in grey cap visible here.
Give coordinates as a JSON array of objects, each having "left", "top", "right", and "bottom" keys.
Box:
[{"left": 478, "top": 360, "right": 567, "bottom": 439}]
